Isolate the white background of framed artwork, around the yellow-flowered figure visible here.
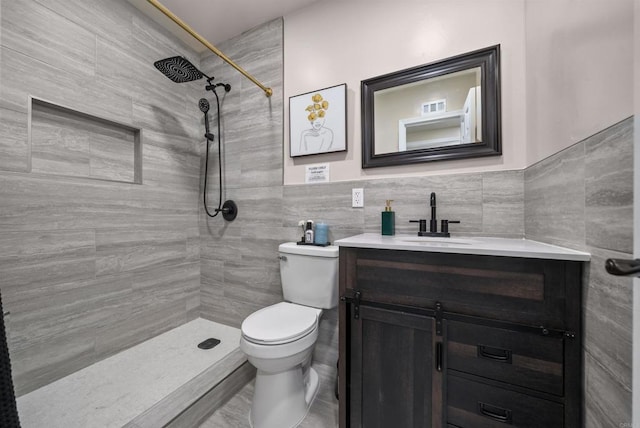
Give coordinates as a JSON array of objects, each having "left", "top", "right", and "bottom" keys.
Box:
[{"left": 289, "top": 83, "right": 347, "bottom": 158}]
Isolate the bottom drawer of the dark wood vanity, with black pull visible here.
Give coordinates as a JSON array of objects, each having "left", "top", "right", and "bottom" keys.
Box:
[{"left": 447, "top": 375, "right": 564, "bottom": 428}]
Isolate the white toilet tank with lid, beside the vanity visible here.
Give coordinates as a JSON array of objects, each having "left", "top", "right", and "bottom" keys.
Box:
[{"left": 278, "top": 242, "right": 338, "bottom": 309}]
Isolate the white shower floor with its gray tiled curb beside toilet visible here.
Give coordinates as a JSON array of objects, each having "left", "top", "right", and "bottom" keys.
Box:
[{"left": 17, "top": 318, "right": 255, "bottom": 428}]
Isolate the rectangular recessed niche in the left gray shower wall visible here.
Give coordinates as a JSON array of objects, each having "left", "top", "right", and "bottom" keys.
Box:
[{"left": 29, "top": 97, "right": 142, "bottom": 184}]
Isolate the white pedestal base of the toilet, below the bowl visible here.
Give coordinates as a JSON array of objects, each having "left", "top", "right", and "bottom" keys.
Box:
[{"left": 249, "top": 365, "right": 320, "bottom": 428}]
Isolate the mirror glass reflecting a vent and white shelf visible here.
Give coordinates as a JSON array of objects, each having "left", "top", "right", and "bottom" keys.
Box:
[{"left": 374, "top": 67, "right": 482, "bottom": 154}]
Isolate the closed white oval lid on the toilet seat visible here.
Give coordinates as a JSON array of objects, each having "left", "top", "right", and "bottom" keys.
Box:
[{"left": 241, "top": 302, "right": 318, "bottom": 345}]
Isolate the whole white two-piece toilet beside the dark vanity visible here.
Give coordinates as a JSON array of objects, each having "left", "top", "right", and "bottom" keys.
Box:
[{"left": 240, "top": 242, "right": 338, "bottom": 428}]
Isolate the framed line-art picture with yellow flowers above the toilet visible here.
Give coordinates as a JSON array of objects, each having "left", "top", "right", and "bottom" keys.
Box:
[{"left": 289, "top": 83, "right": 347, "bottom": 158}]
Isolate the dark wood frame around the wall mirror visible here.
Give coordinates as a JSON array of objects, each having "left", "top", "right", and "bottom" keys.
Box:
[{"left": 360, "top": 45, "right": 502, "bottom": 168}]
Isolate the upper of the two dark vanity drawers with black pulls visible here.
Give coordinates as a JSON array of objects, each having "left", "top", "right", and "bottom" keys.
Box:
[{"left": 446, "top": 321, "right": 571, "bottom": 396}]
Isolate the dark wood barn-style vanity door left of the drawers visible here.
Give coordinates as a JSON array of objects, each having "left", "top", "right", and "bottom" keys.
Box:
[{"left": 349, "top": 305, "right": 441, "bottom": 427}]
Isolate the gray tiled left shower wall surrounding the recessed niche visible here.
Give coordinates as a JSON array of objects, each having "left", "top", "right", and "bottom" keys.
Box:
[{"left": 0, "top": 0, "right": 201, "bottom": 395}]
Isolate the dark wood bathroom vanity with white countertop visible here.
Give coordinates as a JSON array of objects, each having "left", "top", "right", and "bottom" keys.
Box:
[{"left": 336, "top": 234, "right": 590, "bottom": 428}]
